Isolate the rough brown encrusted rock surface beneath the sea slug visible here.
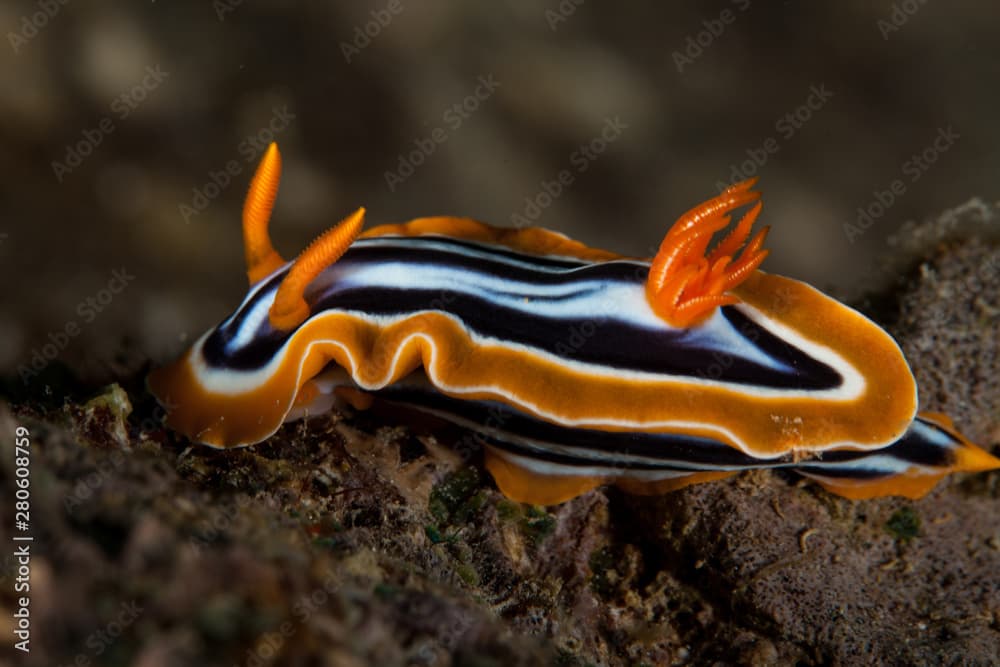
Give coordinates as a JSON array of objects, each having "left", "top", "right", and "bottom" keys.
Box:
[{"left": 0, "top": 201, "right": 1000, "bottom": 667}]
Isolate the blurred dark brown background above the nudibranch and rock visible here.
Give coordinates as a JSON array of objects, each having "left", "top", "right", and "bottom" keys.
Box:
[{"left": 0, "top": 0, "right": 1000, "bottom": 380}]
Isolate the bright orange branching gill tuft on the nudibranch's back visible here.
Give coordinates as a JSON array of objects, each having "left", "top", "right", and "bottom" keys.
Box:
[{"left": 646, "top": 179, "right": 768, "bottom": 327}]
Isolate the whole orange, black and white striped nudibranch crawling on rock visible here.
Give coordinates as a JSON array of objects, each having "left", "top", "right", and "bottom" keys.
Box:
[{"left": 149, "top": 144, "right": 1000, "bottom": 504}]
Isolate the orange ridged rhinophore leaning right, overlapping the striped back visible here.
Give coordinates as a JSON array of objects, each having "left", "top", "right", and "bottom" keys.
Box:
[{"left": 268, "top": 207, "right": 365, "bottom": 331}]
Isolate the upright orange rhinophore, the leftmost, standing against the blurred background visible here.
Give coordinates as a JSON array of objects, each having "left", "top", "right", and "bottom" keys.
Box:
[{"left": 243, "top": 143, "right": 285, "bottom": 285}]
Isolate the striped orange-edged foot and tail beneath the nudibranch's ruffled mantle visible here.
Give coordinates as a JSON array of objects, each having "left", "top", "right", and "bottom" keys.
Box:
[{"left": 336, "top": 373, "right": 1000, "bottom": 505}]
